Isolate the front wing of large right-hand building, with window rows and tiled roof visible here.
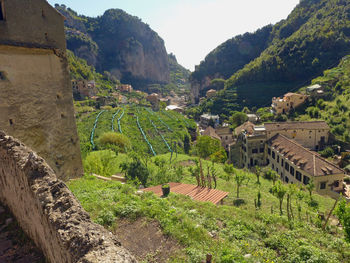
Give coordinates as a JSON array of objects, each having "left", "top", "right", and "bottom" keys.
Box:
[{"left": 267, "top": 134, "right": 345, "bottom": 198}]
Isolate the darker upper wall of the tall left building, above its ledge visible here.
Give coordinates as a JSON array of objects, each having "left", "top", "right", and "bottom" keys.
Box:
[{"left": 0, "top": 0, "right": 66, "bottom": 50}]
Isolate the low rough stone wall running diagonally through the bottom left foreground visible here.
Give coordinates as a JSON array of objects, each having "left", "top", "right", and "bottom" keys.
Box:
[{"left": 0, "top": 131, "right": 136, "bottom": 263}]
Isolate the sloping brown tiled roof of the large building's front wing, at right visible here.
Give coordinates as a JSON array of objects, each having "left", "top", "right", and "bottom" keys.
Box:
[{"left": 268, "top": 134, "right": 345, "bottom": 176}]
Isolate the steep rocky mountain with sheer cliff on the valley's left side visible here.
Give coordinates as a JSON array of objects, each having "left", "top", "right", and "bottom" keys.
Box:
[{"left": 55, "top": 5, "right": 170, "bottom": 89}]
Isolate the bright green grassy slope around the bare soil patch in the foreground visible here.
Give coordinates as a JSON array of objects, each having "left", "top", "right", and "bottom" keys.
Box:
[{"left": 69, "top": 154, "right": 350, "bottom": 263}]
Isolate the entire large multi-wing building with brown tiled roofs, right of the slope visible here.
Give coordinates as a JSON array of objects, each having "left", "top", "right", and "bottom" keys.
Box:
[{"left": 230, "top": 121, "right": 345, "bottom": 198}]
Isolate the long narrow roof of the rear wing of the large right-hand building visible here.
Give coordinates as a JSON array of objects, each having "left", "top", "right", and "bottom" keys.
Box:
[{"left": 264, "top": 121, "right": 329, "bottom": 132}]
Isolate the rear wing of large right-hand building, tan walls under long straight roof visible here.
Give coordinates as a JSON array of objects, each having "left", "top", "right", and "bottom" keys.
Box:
[{"left": 264, "top": 121, "right": 330, "bottom": 151}]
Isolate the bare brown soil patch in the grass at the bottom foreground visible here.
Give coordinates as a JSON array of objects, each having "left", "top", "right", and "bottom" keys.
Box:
[{"left": 115, "top": 218, "right": 182, "bottom": 262}]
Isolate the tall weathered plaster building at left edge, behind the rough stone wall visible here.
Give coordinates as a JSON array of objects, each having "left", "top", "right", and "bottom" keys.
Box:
[{"left": 0, "top": 0, "right": 83, "bottom": 180}]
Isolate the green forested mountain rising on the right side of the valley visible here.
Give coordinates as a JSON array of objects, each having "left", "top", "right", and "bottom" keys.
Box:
[{"left": 191, "top": 0, "right": 350, "bottom": 114}]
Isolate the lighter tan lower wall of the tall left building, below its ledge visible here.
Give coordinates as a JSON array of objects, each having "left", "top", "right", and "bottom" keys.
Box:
[{"left": 0, "top": 45, "right": 83, "bottom": 180}]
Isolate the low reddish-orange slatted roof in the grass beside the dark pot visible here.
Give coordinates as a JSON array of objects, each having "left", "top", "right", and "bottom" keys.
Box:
[{"left": 143, "top": 183, "right": 229, "bottom": 205}]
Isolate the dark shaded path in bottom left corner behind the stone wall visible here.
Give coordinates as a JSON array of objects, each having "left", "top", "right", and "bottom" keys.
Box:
[{"left": 0, "top": 203, "right": 45, "bottom": 263}]
